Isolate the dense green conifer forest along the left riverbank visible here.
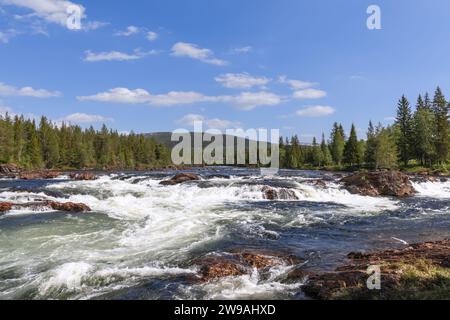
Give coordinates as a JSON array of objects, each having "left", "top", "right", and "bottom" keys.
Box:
[{"left": 0, "top": 114, "right": 171, "bottom": 169}]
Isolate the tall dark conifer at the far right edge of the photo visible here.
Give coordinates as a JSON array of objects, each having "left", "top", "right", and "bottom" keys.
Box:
[{"left": 433, "top": 87, "right": 450, "bottom": 164}]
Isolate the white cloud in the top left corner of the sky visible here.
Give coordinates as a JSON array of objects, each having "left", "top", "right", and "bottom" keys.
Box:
[{"left": 0, "top": 0, "right": 86, "bottom": 27}]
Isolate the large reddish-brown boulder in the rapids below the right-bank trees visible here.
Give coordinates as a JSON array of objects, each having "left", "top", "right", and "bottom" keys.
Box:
[{"left": 341, "top": 171, "right": 416, "bottom": 197}]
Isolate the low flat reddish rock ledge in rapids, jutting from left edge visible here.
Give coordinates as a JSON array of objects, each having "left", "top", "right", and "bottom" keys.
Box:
[{"left": 0, "top": 201, "right": 91, "bottom": 214}]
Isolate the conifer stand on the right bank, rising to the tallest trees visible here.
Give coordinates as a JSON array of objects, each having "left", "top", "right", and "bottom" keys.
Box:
[{"left": 280, "top": 87, "right": 450, "bottom": 170}]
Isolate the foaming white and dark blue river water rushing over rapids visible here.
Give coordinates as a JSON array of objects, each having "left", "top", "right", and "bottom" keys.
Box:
[{"left": 0, "top": 168, "right": 450, "bottom": 299}]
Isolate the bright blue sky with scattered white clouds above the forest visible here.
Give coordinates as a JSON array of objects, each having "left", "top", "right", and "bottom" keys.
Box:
[{"left": 0, "top": 0, "right": 450, "bottom": 142}]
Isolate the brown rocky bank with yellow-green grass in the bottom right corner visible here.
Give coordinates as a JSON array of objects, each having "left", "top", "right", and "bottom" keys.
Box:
[{"left": 303, "top": 240, "right": 450, "bottom": 300}]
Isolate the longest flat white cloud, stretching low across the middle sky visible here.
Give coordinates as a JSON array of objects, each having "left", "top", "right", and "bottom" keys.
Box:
[{"left": 78, "top": 88, "right": 282, "bottom": 110}]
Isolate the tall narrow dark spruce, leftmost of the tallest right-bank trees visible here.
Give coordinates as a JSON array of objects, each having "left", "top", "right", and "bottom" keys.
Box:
[{"left": 395, "top": 96, "right": 414, "bottom": 166}]
